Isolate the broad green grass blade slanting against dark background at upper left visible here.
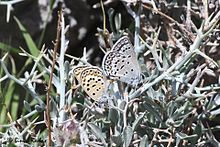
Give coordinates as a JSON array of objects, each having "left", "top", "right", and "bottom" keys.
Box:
[{"left": 14, "top": 17, "right": 39, "bottom": 57}]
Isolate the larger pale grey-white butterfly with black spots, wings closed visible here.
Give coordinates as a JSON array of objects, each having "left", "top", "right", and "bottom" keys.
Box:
[{"left": 102, "top": 36, "right": 143, "bottom": 87}]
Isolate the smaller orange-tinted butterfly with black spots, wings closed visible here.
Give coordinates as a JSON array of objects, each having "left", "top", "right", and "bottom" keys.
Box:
[{"left": 73, "top": 66, "right": 109, "bottom": 101}]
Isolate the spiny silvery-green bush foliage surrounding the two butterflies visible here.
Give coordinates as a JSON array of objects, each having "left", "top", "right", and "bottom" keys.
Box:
[{"left": 0, "top": 0, "right": 220, "bottom": 147}]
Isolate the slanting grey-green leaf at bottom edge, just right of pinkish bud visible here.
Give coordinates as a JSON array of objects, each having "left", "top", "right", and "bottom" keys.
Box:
[{"left": 88, "top": 123, "right": 107, "bottom": 146}]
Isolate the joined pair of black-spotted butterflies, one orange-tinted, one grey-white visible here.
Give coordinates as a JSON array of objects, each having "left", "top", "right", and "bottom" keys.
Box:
[{"left": 74, "top": 36, "right": 142, "bottom": 101}]
